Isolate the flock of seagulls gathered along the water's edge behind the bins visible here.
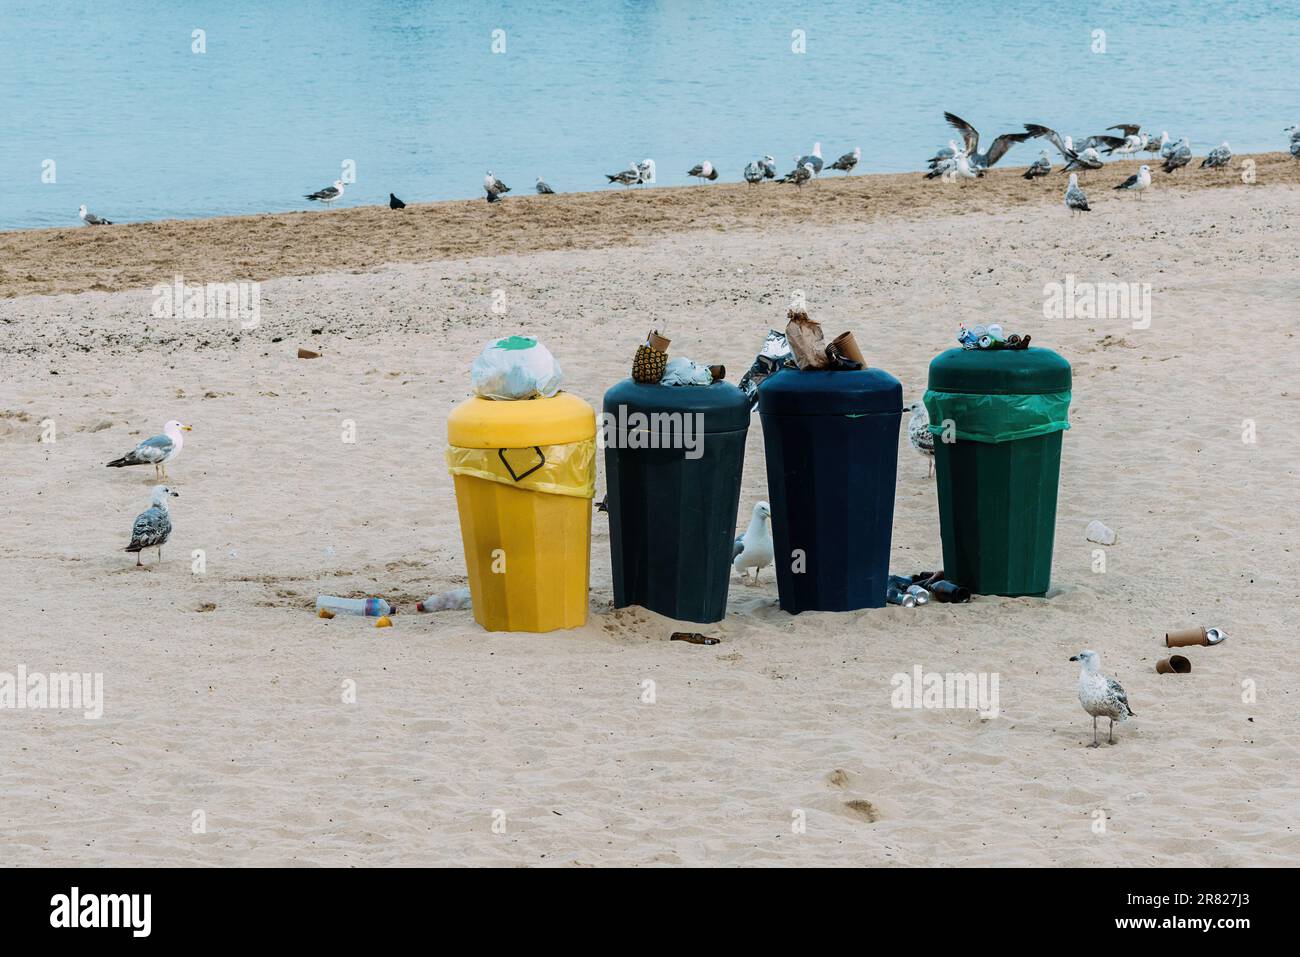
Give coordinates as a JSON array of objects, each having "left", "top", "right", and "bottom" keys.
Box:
[{"left": 79, "top": 120, "right": 1300, "bottom": 226}]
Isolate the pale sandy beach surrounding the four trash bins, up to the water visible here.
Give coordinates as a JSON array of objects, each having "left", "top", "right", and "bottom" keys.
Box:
[{"left": 0, "top": 162, "right": 1300, "bottom": 867}]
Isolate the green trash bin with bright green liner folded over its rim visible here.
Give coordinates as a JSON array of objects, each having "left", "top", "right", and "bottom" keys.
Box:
[{"left": 926, "top": 346, "right": 1070, "bottom": 596}]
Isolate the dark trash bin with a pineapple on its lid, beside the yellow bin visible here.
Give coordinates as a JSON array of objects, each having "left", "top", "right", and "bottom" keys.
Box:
[{"left": 602, "top": 378, "right": 750, "bottom": 623}]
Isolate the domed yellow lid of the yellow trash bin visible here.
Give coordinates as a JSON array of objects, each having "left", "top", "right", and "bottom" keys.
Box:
[{"left": 447, "top": 393, "right": 595, "bottom": 449}]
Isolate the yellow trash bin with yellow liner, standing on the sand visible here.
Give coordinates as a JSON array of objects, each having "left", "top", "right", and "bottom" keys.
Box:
[{"left": 447, "top": 393, "right": 595, "bottom": 632}]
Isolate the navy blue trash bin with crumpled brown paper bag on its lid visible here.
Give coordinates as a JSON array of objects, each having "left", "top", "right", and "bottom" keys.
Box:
[{"left": 758, "top": 369, "right": 902, "bottom": 614}]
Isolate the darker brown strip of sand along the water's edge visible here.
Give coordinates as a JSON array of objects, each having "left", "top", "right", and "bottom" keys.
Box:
[{"left": 0, "top": 152, "right": 1300, "bottom": 299}]
